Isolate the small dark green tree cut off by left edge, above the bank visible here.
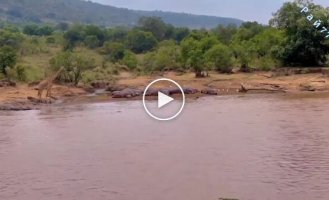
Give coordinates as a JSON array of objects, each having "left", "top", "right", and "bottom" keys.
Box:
[{"left": 0, "top": 46, "right": 17, "bottom": 77}]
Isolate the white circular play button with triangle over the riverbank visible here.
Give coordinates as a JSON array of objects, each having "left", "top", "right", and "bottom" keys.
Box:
[{"left": 143, "top": 78, "right": 185, "bottom": 121}]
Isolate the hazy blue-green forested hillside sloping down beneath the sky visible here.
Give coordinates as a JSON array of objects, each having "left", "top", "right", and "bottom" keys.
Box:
[{"left": 0, "top": 0, "right": 242, "bottom": 28}]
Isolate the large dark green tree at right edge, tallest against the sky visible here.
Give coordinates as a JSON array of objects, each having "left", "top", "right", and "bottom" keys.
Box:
[{"left": 270, "top": 0, "right": 329, "bottom": 66}]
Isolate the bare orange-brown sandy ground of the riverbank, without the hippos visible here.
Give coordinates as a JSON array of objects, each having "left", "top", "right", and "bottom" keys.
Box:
[{"left": 0, "top": 72, "right": 329, "bottom": 108}]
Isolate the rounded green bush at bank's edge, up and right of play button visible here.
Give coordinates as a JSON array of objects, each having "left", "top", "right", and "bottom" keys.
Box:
[{"left": 205, "top": 44, "right": 232, "bottom": 73}]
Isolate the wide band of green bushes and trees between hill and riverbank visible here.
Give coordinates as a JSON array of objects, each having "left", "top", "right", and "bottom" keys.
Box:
[{"left": 0, "top": 1, "right": 329, "bottom": 85}]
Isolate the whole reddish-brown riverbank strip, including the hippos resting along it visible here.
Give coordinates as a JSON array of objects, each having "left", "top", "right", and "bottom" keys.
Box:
[{"left": 0, "top": 72, "right": 329, "bottom": 110}]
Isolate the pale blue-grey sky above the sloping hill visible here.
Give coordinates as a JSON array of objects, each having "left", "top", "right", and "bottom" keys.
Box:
[{"left": 92, "top": 0, "right": 329, "bottom": 24}]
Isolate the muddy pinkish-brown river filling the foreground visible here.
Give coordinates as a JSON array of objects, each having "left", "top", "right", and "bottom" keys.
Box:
[{"left": 0, "top": 95, "right": 329, "bottom": 200}]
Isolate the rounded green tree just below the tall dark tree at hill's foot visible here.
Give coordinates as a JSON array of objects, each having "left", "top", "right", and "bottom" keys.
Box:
[{"left": 127, "top": 30, "right": 158, "bottom": 53}]
